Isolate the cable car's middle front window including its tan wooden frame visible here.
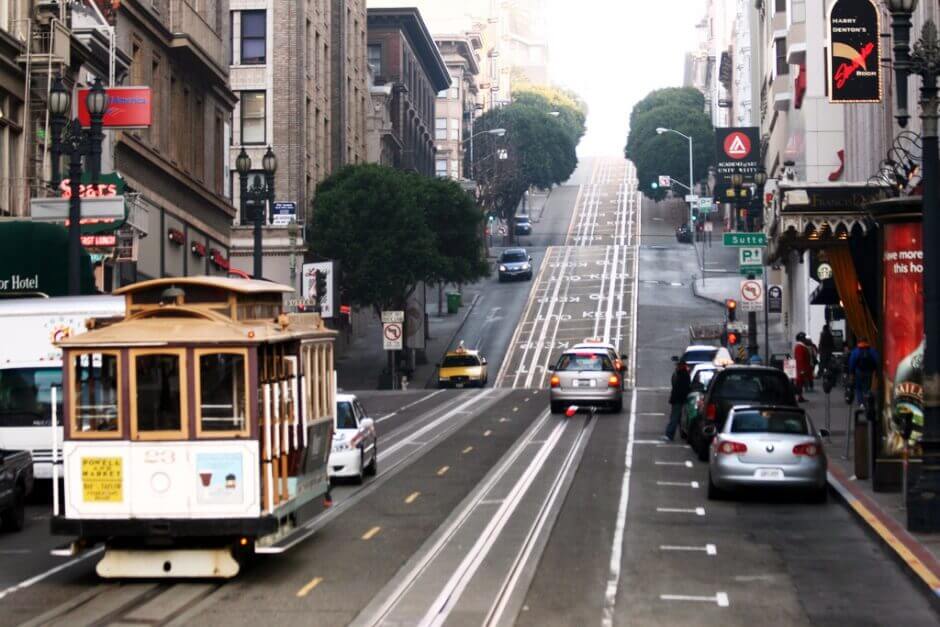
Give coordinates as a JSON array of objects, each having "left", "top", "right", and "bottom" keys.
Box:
[{"left": 131, "top": 350, "right": 187, "bottom": 440}]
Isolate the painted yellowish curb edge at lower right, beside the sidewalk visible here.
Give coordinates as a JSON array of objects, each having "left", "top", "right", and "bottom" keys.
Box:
[{"left": 826, "top": 466, "right": 940, "bottom": 608}]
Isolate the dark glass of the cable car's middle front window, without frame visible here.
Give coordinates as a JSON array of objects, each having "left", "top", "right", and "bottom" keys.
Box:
[{"left": 134, "top": 351, "right": 184, "bottom": 433}]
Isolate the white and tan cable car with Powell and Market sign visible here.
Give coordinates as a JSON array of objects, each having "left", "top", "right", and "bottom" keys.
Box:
[{"left": 51, "top": 277, "right": 336, "bottom": 578}]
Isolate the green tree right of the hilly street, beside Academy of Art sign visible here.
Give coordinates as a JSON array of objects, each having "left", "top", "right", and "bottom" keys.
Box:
[{"left": 624, "top": 88, "right": 715, "bottom": 200}]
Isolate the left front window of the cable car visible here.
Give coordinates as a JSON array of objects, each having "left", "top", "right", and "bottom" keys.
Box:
[{"left": 71, "top": 353, "right": 121, "bottom": 437}]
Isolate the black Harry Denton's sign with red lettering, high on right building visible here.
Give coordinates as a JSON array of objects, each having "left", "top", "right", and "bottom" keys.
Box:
[{"left": 828, "top": 0, "right": 881, "bottom": 103}]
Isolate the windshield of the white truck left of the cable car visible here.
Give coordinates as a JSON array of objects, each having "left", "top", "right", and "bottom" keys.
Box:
[{"left": 0, "top": 368, "right": 62, "bottom": 427}]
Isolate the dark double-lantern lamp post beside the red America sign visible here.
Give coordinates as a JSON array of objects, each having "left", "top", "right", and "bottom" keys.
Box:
[{"left": 49, "top": 78, "right": 108, "bottom": 296}]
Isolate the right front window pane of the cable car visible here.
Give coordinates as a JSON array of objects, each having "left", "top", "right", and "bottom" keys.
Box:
[{"left": 196, "top": 351, "right": 248, "bottom": 436}]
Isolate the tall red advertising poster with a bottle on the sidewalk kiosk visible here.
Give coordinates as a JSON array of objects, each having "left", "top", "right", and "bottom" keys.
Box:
[{"left": 882, "top": 222, "right": 924, "bottom": 456}]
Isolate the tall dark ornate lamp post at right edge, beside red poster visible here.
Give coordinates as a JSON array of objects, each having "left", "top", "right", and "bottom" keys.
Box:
[{"left": 887, "top": 0, "right": 940, "bottom": 533}]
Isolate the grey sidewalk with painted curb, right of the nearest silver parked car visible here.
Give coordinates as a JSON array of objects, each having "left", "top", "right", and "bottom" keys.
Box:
[{"left": 803, "top": 392, "right": 940, "bottom": 605}]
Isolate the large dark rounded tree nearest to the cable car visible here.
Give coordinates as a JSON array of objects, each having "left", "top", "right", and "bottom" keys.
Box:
[{"left": 307, "top": 164, "right": 441, "bottom": 312}]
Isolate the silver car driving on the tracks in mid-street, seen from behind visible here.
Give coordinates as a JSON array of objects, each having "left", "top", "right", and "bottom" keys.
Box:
[{"left": 549, "top": 350, "right": 623, "bottom": 414}]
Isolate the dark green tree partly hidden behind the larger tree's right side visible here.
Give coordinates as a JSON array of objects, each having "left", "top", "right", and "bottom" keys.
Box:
[{"left": 411, "top": 174, "right": 490, "bottom": 284}]
